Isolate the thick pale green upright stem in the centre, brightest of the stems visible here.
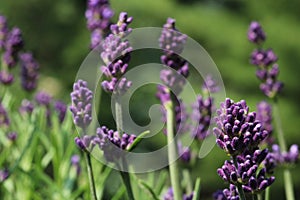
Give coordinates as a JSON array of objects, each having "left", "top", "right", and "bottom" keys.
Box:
[{"left": 164, "top": 101, "right": 182, "bottom": 200}]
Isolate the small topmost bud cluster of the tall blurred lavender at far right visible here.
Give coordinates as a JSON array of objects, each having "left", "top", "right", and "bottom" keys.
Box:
[{"left": 248, "top": 22, "right": 266, "bottom": 44}]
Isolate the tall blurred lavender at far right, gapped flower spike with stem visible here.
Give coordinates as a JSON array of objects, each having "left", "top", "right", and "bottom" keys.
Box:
[{"left": 248, "top": 22, "right": 298, "bottom": 200}]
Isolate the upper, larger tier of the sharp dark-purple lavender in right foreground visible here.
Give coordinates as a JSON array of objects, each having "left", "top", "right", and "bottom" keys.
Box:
[{"left": 214, "top": 98, "right": 268, "bottom": 156}]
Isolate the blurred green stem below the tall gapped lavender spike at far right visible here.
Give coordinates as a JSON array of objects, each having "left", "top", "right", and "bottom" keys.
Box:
[{"left": 273, "top": 98, "right": 295, "bottom": 200}]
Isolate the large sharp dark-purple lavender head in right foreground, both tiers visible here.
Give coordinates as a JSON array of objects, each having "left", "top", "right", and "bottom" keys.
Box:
[{"left": 214, "top": 98, "right": 275, "bottom": 199}]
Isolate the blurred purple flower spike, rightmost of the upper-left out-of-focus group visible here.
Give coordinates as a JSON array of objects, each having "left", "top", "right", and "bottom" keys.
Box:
[{"left": 20, "top": 53, "right": 39, "bottom": 91}]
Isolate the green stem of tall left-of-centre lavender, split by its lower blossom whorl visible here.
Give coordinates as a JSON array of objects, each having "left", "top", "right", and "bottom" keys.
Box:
[{"left": 115, "top": 99, "right": 134, "bottom": 200}]
